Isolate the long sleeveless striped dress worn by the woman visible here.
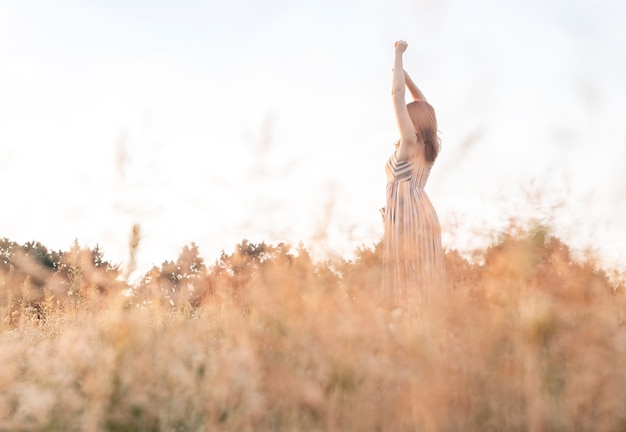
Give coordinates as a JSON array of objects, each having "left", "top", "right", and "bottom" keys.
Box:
[{"left": 381, "top": 152, "right": 445, "bottom": 310}]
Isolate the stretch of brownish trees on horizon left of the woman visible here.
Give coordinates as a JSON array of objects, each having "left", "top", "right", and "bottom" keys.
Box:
[{"left": 0, "top": 238, "right": 382, "bottom": 318}]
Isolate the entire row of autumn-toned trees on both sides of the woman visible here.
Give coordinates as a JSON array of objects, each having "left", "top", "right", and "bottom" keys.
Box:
[{"left": 0, "top": 228, "right": 624, "bottom": 322}]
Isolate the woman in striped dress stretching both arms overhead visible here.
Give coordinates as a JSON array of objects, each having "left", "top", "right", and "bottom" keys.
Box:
[{"left": 382, "top": 41, "right": 445, "bottom": 310}]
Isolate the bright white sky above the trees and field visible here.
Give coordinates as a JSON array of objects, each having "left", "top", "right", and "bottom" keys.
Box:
[{"left": 0, "top": 0, "right": 626, "bottom": 276}]
